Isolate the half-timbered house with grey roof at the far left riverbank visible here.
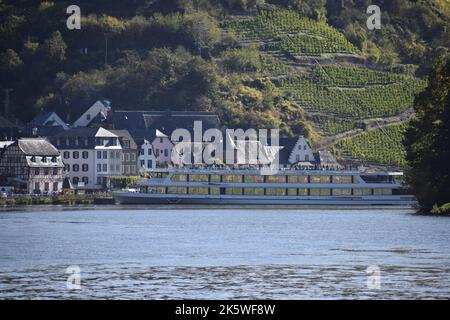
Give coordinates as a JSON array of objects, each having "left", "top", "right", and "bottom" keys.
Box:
[{"left": 0, "top": 138, "right": 64, "bottom": 194}]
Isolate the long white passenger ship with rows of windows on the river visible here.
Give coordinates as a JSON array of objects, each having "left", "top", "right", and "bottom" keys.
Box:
[{"left": 113, "top": 168, "right": 415, "bottom": 206}]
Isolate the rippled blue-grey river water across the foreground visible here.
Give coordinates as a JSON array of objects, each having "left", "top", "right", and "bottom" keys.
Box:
[{"left": 0, "top": 209, "right": 450, "bottom": 299}]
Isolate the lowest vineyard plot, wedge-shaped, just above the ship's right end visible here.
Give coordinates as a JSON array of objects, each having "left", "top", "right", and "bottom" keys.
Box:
[{"left": 336, "top": 122, "right": 406, "bottom": 166}]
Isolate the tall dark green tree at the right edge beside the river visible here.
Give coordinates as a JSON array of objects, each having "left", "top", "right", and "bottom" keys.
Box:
[{"left": 404, "top": 57, "right": 450, "bottom": 212}]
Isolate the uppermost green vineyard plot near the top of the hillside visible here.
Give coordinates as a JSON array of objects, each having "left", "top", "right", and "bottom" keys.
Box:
[{"left": 226, "top": 10, "right": 358, "bottom": 56}]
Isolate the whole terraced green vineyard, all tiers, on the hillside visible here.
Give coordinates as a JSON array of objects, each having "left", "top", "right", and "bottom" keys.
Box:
[{"left": 225, "top": 10, "right": 426, "bottom": 166}]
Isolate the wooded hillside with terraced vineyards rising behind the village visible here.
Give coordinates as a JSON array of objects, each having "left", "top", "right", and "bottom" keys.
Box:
[{"left": 0, "top": 0, "right": 450, "bottom": 166}]
